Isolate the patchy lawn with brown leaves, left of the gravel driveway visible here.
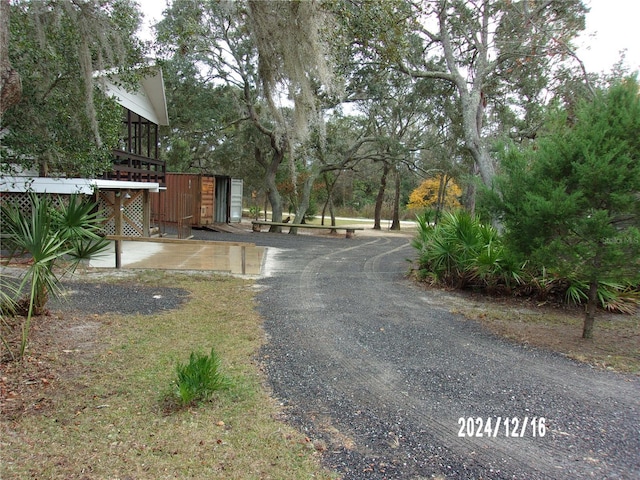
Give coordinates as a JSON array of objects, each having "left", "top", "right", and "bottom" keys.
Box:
[{"left": 0, "top": 271, "right": 333, "bottom": 479}]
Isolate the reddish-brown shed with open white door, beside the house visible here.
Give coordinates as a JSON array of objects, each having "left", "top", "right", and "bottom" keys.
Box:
[{"left": 151, "top": 173, "right": 243, "bottom": 228}]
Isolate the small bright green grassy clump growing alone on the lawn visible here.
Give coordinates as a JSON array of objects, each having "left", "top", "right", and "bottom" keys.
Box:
[{"left": 175, "top": 348, "right": 231, "bottom": 406}]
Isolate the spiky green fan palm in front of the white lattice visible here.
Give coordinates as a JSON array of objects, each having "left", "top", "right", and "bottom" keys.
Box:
[{"left": 1, "top": 193, "right": 108, "bottom": 357}]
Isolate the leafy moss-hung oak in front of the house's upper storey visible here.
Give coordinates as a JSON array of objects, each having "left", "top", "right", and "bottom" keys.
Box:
[{"left": 1, "top": 0, "right": 142, "bottom": 177}]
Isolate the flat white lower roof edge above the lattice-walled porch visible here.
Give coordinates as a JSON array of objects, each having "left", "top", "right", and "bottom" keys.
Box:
[{"left": 0, "top": 176, "right": 160, "bottom": 195}]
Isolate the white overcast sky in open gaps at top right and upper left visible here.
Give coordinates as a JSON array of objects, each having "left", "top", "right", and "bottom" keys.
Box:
[{"left": 138, "top": 0, "right": 640, "bottom": 73}]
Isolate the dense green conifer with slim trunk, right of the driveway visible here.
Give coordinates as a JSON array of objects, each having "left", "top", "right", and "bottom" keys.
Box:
[{"left": 499, "top": 79, "right": 640, "bottom": 338}]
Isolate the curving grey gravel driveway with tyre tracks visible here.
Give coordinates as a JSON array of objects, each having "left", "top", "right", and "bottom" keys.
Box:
[{"left": 251, "top": 234, "right": 640, "bottom": 480}]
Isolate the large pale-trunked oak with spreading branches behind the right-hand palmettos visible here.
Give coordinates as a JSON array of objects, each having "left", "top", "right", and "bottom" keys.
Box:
[{"left": 334, "top": 0, "right": 586, "bottom": 191}]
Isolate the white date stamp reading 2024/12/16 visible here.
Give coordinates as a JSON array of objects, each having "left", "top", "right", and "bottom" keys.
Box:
[{"left": 458, "top": 417, "right": 547, "bottom": 438}]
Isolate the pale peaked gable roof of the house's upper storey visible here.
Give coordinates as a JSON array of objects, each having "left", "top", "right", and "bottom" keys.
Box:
[{"left": 97, "top": 67, "right": 169, "bottom": 125}]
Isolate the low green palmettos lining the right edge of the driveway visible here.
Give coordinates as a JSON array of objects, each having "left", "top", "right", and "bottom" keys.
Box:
[{"left": 411, "top": 211, "right": 640, "bottom": 313}]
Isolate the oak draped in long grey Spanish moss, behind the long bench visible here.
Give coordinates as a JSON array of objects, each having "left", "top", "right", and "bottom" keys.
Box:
[{"left": 158, "top": 0, "right": 331, "bottom": 228}]
